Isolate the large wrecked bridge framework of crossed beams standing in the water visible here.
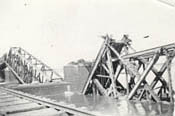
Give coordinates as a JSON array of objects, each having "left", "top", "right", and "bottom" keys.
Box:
[{"left": 82, "top": 35, "right": 175, "bottom": 103}]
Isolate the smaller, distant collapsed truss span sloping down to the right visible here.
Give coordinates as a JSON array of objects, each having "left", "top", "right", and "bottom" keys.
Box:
[{"left": 4, "top": 47, "right": 62, "bottom": 84}]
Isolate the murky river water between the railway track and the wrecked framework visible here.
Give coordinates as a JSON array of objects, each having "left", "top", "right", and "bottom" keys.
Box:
[{"left": 15, "top": 89, "right": 174, "bottom": 116}]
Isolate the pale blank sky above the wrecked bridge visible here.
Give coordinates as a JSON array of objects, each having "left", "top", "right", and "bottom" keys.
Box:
[{"left": 0, "top": 0, "right": 175, "bottom": 68}]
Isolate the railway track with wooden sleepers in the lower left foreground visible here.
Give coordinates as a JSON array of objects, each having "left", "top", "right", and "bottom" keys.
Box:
[{"left": 0, "top": 87, "right": 100, "bottom": 116}]
